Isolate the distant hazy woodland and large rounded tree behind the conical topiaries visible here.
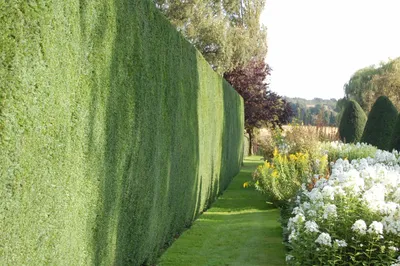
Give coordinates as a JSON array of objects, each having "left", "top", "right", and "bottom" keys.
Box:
[{"left": 285, "top": 57, "right": 400, "bottom": 129}]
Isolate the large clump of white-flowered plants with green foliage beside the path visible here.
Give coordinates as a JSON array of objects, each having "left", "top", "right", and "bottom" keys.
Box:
[{"left": 286, "top": 149, "right": 400, "bottom": 265}]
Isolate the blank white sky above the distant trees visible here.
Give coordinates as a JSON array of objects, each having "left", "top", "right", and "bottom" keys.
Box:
[{"left": 261, "top": 0, "right": 400, "bottom": 99}]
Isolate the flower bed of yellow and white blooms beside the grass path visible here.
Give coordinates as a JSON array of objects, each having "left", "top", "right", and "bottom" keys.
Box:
[{"left": 248, "top": 139, "right": 400, "bottom": 266}]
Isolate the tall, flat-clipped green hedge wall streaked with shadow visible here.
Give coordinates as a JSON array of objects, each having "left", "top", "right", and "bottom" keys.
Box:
[{"left": 0, "top": 0, "right": 244, "bottom": 265}]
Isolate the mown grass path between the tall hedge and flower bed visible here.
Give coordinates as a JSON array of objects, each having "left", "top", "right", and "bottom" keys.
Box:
[{"left": 158, "top": 156, "right": 285, "bottom": 266}]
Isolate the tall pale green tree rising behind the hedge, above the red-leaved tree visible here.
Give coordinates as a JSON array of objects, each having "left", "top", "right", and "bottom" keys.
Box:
[{"left": 154, "top": 0, "right": 267, "bottom": 74}]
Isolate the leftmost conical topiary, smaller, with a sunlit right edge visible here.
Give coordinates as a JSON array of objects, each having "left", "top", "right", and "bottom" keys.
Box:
[{"left": 339, "top": 100, "right": 367, "bottom": 143}]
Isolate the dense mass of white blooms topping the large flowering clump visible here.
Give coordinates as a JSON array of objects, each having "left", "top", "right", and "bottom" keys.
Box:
[{"left": 312, "top": 158, "right": 400, "bottom": 227}]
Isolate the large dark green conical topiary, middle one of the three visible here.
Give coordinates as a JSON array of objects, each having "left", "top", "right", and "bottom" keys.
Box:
[{"left": 361, "top": 96, "right": 397, "bottom": 150}]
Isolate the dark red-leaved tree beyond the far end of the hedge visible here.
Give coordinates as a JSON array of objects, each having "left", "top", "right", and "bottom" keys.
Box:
[{"left": 224, "top": 60, "right": 293, "bottom": 155}]
